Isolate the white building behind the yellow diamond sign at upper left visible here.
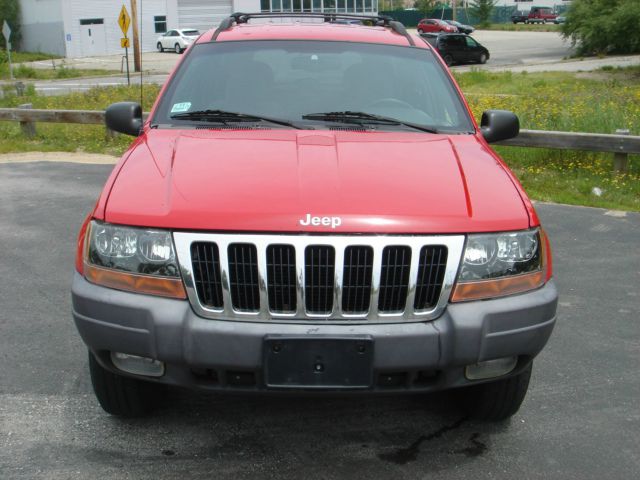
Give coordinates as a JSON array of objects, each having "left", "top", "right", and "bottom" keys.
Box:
[{"left": 20, "top": 0, "right": 260, "bottom": 58}]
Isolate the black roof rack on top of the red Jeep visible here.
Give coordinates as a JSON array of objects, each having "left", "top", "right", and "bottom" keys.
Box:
[{"left": 211, "top": 12, "right": 415, "bottom": 47}]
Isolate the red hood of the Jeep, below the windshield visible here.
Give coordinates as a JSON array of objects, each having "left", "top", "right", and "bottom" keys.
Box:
[{"left": 105, "top": 130, "right": 529, "bottom": 233}]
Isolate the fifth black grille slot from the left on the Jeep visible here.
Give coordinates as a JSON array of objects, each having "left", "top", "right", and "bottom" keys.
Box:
[{"left": 342, "top": 246, "right": 373, "bottom": 314}]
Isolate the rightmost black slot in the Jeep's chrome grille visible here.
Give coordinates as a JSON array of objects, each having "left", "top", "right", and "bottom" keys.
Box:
[{"left": 413, "top": 245, "right": 448, "bottom": 310}]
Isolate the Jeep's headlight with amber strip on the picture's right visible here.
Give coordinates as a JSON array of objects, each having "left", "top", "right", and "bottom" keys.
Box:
[{"left": 451, "top": 229, "right": 546, "bottom": 302}]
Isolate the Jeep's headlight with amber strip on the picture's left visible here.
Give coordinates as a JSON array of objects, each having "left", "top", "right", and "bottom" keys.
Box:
[{"left": 84, "top": 221, "right": 186, "bottom": 298}]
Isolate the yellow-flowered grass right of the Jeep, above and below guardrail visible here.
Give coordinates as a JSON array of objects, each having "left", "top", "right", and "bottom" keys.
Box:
[{"left": 456, "top": 68, "right": 640, "bottom": 211}]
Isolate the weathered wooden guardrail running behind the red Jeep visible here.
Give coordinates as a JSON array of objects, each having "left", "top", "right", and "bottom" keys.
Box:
[{"left": 0, "top": 104, "right": 640, "bottom": 172}]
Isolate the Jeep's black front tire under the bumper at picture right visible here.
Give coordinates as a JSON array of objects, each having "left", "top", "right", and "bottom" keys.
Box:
[{"left": 458, "top": 363, "right": 533, "bottom": 421}]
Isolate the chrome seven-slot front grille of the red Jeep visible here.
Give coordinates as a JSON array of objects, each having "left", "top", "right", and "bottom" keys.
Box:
[{"left": 174, "top": 232, "right": 464, "bottom": 323}]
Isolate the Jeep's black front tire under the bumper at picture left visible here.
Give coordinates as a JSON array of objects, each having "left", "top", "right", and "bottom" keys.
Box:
[{"left": 89, "top": 352, "right": 159, "bottom": 418}]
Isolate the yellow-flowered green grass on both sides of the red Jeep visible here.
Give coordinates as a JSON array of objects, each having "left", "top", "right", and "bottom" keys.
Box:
[{"left": 0, "top": 68, "right": 640, "bottom": 211}]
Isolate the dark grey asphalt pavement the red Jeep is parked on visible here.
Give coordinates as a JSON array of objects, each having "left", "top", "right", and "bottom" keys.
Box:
[{"left": 0, "top": 162, "right": 640, "bottom": 480}]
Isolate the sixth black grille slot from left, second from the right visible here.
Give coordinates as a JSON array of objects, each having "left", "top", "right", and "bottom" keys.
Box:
[{"left": 378, "top": 246, "right": 411, "bottom": 313}]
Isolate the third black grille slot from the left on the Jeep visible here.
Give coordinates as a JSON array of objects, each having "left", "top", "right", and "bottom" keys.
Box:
[{"left": 267, "top": 245, "right": 296, "bottom": 313}]
